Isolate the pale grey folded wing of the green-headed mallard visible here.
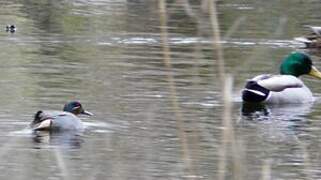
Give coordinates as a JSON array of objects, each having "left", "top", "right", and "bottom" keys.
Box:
[{"left": 257, "top": 75, "right": 304, "bottom": 92}]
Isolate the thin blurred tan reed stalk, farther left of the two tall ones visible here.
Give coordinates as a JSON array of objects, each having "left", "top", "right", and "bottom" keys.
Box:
[{"left": 158, "top": 0, "right": 194, "bottom": 177}]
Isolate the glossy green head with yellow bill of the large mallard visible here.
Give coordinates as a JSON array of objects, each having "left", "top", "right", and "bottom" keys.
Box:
[{"left": 280, "top": 52, "right": 321, "bottom": 79}]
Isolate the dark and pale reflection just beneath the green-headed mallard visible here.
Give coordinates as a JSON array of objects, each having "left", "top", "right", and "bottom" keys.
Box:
[{"left": 241, "top": 104, "right": 313, "bottom": 145}]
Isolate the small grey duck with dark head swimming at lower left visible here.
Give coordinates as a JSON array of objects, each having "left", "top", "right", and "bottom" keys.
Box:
[{"left": 30, "top": 101, "right": 93, "bottom": 131}]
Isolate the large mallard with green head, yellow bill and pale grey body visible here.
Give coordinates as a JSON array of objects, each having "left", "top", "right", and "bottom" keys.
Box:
[{"left": 242, "top": 52, "right": 321, "bottom": 104}]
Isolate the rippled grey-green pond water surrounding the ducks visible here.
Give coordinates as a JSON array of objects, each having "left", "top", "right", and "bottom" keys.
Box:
[{"left": 0, "top": 0, "right": 321, "bottom": 180}]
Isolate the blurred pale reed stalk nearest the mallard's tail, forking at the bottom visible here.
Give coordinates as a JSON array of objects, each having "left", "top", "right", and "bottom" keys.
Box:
[{"left": 208, "top": 0, "right": 242, "bottom": 180}]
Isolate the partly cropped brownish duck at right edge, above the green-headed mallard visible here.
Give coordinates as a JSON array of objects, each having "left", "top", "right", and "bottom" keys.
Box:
[{"left": 294, "top": 26, "right": 321, "bottom": 48}]
